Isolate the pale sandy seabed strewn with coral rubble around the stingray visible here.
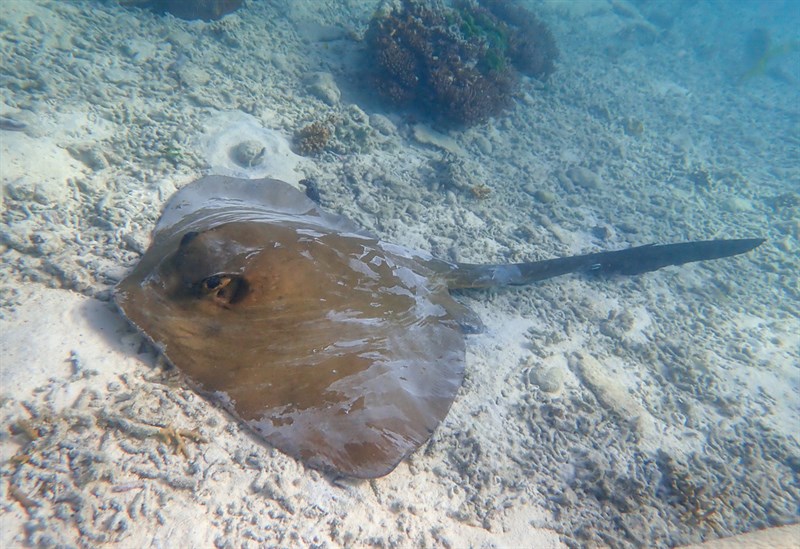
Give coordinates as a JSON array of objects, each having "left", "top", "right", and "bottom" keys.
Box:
[{"left": 0, "top": 0, "right": 800, "bottom": 547}]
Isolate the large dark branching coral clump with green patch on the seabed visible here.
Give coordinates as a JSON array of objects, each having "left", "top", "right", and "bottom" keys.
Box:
[{"left": 366, "top": 0, "right": 558, "bottom": 125}]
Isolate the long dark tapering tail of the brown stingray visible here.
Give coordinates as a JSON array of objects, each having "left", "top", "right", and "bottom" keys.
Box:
[{"left": 446, "top": 238, "right": 764, "bottom": 289}]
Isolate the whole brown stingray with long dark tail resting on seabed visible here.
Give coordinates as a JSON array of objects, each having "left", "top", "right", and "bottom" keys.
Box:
[{"left": 115, "top": 176, "right": 763, "bottom": 478}]
